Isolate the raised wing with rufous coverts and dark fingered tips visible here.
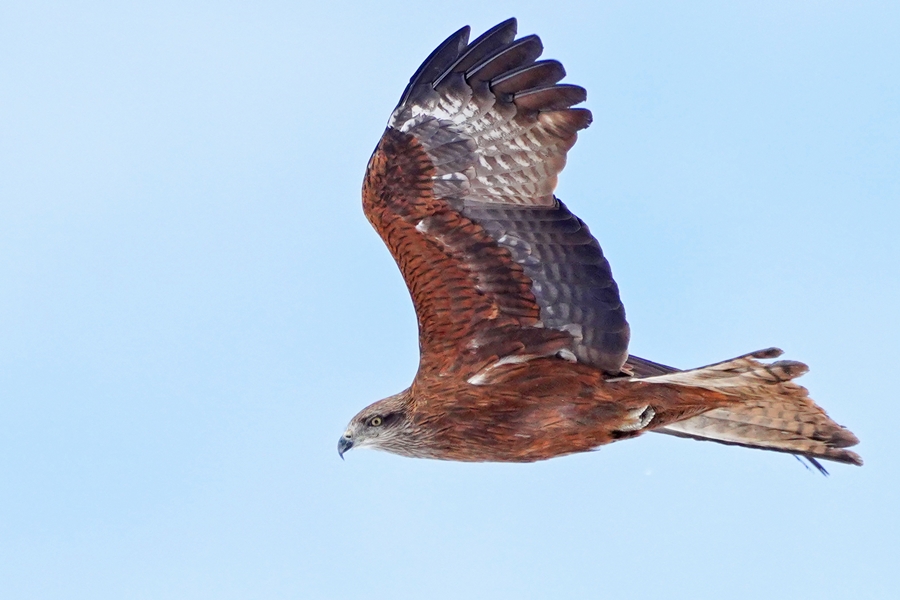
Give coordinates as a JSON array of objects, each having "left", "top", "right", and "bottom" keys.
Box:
[{"left": 363, "top": 19, "right": 629, "bottom": 375}]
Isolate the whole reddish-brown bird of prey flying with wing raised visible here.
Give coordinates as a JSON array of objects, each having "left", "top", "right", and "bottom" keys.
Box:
[{"left": 338, "top": 19, "right": 862, "bottom": 471}]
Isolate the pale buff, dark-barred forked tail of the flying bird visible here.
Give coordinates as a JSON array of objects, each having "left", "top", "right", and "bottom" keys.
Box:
[{"left": 630, "top": 348, "right": 863, "bottom": 471}]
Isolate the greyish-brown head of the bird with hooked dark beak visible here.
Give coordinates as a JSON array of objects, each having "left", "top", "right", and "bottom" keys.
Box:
[{"left": 338, "top": 392, "right": 411, "bottom": 458}]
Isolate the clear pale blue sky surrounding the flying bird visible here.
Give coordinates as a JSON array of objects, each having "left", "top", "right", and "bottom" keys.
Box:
[{"left": 0, "top": 0, "right": 900, "bottom": 600}]
